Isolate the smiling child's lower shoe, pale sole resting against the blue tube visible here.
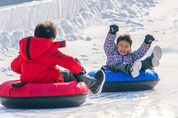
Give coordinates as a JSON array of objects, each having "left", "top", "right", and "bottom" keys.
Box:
[{"left": 130, "top": 60, "right": 142, "bottom": 78}]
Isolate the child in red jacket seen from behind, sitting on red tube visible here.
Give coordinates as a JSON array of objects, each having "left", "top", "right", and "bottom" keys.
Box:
[{"left": 11, "top": 22, "right": 105, "bottom": 96}]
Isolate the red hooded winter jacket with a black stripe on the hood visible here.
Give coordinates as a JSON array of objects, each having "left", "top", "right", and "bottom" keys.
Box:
[{"left": 11, "top": 37, "right": 82, "bottom": 83}]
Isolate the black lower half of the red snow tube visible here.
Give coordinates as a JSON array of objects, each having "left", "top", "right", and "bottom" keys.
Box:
[{"left": 0, "top": 93, "right": 88, "bottom": 109}]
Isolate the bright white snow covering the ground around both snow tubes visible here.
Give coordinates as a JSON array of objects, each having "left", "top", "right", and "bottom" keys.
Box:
[{"left": 0, "top": 0, "right": 178, "bottom": 118}]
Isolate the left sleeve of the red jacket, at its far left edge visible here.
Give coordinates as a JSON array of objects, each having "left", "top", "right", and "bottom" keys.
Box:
[{"left": 11, "top": 56, "right": 21, "bottom": 74}]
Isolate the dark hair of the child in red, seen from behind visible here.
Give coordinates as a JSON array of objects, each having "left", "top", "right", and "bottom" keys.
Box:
[{"left": 34, "top": 21, "right": 57, "bottom": 39}]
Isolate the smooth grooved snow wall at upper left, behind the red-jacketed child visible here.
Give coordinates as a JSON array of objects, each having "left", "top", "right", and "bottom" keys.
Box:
[{"left": 0, "top": 0, "right": 87, "bottom": 31}]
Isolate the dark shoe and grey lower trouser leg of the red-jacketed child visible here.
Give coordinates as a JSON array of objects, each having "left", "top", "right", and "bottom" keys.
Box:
[{"left": 80, "top": 70, "right": 105, "bottom": 96}]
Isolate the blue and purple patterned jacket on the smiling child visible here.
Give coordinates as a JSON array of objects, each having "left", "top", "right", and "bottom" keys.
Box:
[{"left": 104, "top": 33, "right": 150, "bottom": 66}]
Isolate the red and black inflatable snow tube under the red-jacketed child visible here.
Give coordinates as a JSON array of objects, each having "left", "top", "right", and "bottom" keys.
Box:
[{"left": 0, "top": 80, "right": 89, "bottom": 109}]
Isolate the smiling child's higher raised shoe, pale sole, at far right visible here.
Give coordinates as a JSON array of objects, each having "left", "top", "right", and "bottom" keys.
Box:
[{"left": 151, "top": 46, "right": 162, "bottom": 67}]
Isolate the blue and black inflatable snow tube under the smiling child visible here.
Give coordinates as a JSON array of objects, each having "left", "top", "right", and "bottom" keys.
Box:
[{"left": 88, "top": 69, "right": 160, "bottom": 92}]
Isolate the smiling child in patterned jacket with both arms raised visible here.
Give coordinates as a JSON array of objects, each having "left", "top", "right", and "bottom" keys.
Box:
[{"left": 104, "top": 25, "right": 162, "bottom": 77}]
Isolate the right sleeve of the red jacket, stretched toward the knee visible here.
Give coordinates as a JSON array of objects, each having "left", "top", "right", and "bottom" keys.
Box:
[{"left": 51, "top": 50, "right": 82, "bottom": 74}]
